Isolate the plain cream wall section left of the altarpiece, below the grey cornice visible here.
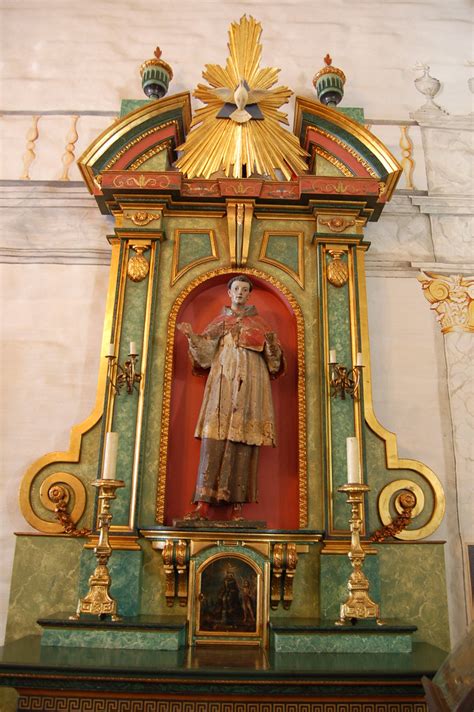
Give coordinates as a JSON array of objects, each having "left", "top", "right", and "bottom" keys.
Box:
[{"left": 0, "top": 264, "right": 109, "bottom": 641}]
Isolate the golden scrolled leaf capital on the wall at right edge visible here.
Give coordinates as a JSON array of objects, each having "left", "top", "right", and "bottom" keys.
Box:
[{"left": 417, "top": 272, "right": 474, "bottom": 334}]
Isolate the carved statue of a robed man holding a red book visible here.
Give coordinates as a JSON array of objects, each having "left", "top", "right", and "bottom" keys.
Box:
[{"left": 177, "top": 274, "right": 285, "bottom": 520}]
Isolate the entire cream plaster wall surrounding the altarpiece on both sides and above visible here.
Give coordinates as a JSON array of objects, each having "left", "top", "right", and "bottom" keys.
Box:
[{"left": 0, "top": 0, "right": 473, "bottom": 640}]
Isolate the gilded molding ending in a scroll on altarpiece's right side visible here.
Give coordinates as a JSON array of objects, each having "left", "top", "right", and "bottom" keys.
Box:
[{"left": 357, "top": 246, "right": 446, "bottom": 541}]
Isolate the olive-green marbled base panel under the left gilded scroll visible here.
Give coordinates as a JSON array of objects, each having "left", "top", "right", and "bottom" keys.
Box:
[{"left": 5, "top": 534, "right": 84, "bottom": 642}]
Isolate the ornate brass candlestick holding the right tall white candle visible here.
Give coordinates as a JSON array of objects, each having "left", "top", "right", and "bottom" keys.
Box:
[{"left": 336, "top": 482, "right": 383, "bottom": 625}]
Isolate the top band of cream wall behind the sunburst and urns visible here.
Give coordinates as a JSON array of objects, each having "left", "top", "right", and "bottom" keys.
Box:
[{"left": 1, "top": 0, "right": 472, "bottom": 119}]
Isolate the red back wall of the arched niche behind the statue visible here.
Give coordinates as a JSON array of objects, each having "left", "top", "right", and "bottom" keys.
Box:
[{"left": 164, "top": 274, "right": 299, "bottom": 529}]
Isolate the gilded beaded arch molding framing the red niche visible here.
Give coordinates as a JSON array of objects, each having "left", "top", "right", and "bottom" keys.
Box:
[{"left": 156, "top": 267, "right": 308, "bottom": 527}]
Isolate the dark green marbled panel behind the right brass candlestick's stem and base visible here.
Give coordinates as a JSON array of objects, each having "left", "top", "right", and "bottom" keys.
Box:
[{"left": 320, "top": 554, "right": 382, "bottom": 623}]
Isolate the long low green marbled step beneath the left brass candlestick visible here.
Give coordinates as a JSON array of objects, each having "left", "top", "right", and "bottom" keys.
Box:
[{"left": 41, "top": 628, "right": 185, "bottom": 650}]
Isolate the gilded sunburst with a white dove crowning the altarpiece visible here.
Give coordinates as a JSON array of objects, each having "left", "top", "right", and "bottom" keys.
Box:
[{"left": 176, "top": 15, "right": 308, "bottom": 180}]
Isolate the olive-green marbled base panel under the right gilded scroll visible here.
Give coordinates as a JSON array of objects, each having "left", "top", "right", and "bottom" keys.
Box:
[{"left": 377, "top": 542, "right": 450, "bottom": 650}]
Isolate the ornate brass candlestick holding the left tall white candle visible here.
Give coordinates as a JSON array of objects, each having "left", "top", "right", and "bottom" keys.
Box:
[{"left": 70, "top": 479, "right": 125, "bottom": 621}]
